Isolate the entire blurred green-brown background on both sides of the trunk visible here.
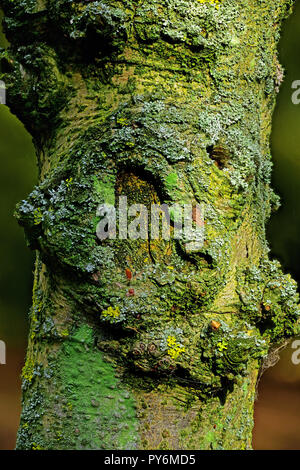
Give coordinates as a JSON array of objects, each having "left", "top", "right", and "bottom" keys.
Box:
[{"left": 0, "top": 1, "right": 300, "bottom": 450}]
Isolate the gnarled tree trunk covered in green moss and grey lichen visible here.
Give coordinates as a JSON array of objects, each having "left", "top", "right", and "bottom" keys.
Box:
[{"left": 2, "top": 0, "right": 299, "bottom": 450}]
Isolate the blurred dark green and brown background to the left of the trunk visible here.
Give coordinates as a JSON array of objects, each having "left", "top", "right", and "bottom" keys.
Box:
[{"left": 0, "top": 8, "right": 37, "bottom": 449}]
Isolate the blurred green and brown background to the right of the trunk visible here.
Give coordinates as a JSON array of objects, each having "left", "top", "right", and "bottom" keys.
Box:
[{"left": 253, "top": 0, "right": 300, "bottom": 450}]
